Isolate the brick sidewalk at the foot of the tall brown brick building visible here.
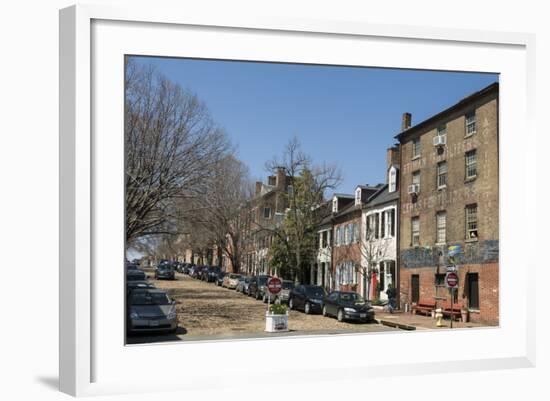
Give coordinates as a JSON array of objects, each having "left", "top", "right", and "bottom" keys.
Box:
[{"left": 375, "top": 308, "right": 487, "bottom": 330}]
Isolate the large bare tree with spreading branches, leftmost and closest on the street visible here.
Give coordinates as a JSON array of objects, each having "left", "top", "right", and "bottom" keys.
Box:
[{"left": 125, "top": 57, "right": 230, "bottom": 244}]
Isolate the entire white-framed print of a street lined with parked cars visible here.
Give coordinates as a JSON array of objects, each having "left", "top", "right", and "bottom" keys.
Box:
[{"left": 60, "top": 6, "right": 536, "bottom": 395}]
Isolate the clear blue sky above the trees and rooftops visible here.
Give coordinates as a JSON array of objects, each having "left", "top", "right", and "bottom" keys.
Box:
[{"left": 130, "top": 57, "right": 498, "bottom": 195}]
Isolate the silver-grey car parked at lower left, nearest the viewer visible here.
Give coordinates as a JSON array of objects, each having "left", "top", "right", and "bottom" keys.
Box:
[{"left": 127, "top": 289, "right": 178, "bottom": 333}]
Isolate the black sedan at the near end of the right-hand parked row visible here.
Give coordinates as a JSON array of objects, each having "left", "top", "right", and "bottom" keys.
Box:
[{"left": 323, "top": 291, "right": 374, "bottom": 322}]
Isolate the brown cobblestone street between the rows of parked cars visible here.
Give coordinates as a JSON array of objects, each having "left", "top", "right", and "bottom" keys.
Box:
[{"left": 128, "top": 273, "right": 398, "bottom": 344}]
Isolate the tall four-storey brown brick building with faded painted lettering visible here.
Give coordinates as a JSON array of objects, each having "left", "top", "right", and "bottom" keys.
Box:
[{"left": 396, "top": 83, "right": 499, "bottom": 324}]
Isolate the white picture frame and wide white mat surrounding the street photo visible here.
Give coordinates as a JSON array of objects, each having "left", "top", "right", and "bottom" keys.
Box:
[{"left": 60, "top": 5, "right": 537, "bottom": 396}]
